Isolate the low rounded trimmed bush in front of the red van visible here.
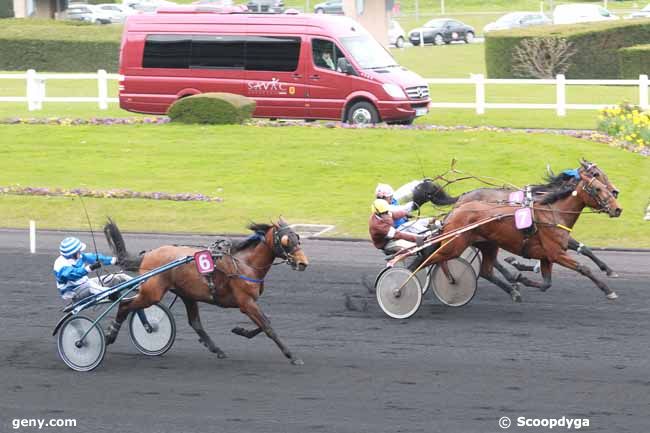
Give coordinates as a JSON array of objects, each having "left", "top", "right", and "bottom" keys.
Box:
[{"left": 167, "top": 93, "right": 255, "bottom": 125}]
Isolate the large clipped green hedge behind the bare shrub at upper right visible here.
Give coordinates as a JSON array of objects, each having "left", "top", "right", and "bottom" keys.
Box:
[{"left": 485, "top": 19, "right": 650, "bottom": 79}]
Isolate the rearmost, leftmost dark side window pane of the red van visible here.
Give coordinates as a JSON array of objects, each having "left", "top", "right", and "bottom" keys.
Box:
[{"left": 142, "top": 35, "right": 192, "bottom": 69}]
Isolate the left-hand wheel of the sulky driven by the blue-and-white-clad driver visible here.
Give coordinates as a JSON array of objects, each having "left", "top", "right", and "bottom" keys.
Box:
[{"left": 57, "top": 316, "right": 106, "bottom": 371}]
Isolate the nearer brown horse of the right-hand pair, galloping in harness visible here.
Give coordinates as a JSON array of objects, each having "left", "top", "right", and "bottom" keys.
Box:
[{"left": 418, "top": 161, "right": 622, "bottom": 300}]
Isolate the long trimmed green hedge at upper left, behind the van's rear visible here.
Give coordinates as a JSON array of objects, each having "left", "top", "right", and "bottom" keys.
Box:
[{"left": 0, "top": 18, "right": 122, "bottom": 72}]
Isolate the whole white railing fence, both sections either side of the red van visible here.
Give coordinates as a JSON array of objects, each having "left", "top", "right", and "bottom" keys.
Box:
[{"left": 0, "top": 69, "right": 650, "bottom": 116}]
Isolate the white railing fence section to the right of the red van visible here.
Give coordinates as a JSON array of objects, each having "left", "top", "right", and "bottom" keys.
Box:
[{"left": 425, "top": 74, "right": 650, "bottom": 116}]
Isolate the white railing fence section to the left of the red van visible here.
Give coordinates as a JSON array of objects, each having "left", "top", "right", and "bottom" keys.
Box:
[{"left": 0, "top": 69, "right": 122, "bottom": 111}]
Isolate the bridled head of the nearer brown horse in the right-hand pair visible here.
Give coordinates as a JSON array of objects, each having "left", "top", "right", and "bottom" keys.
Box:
[{"left": 575, "top": 165, "right": 623, "bottom": 218}]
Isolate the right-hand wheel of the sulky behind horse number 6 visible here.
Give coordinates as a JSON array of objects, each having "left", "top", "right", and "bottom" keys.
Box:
[{"left": 129, "top": 304, "right": 176, "bottom": 356}]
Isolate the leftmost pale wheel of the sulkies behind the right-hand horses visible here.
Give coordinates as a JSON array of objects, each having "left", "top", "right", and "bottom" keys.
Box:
[{"left": 376, "top": 268, "right": 422, "bottom": 319}]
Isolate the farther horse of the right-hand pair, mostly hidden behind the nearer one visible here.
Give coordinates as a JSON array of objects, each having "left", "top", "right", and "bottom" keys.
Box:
[{"left": 413, "top": 161, "right": 618, "bottom": 278}]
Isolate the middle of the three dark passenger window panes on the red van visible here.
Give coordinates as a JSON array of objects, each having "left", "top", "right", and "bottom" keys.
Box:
[{"left": 190, "top": 35, "right": 245, "bottom": 69}]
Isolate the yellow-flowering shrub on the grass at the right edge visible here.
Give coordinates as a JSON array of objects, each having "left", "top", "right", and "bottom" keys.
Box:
[{"left": 598, "top": 103, "right": 650, "bottom": 151}]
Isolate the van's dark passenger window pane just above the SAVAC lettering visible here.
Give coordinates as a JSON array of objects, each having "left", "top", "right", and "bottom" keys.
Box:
[{"left": 246, "top": 36, "right": 300, "bottom": 72}]
